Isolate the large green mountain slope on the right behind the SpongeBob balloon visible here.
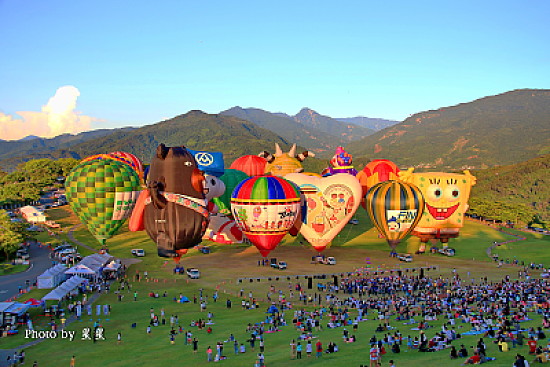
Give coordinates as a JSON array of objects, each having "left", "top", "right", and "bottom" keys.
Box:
[{"left": 347, "top": 89, "right": 550, "bottom": 170}]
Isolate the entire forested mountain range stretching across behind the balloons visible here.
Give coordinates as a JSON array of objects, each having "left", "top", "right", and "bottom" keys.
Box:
[{"left": 0, "top": 89, "right": 550, "bottom": 171}]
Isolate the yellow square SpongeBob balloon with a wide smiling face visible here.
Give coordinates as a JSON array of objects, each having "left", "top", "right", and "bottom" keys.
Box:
[{"left": 399, "top": 168, "right": 476, "bottom": 244}]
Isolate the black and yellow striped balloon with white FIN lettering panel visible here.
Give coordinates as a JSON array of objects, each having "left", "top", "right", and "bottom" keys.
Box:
[{"left": 366, "top": 181, "right": 424, "bottom": 255}]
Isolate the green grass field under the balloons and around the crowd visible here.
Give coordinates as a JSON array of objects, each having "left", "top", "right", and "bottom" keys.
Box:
[{"left": 4, "top": 208, "right": 550, "bottom": 367}]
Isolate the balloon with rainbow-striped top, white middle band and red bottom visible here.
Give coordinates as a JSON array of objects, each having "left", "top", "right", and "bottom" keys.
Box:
[{"left": 231, "top": 175, "right": 300, "bottom": 257}]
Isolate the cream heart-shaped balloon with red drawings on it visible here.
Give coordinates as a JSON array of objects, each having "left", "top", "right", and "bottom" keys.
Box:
[{"left": 285, "top": 173, "right": 361, "bottom": 252}]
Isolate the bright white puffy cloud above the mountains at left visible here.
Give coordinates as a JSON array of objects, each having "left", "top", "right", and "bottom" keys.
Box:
[{"left": 0, "top": 85, "right": 98, "bottom": 140}]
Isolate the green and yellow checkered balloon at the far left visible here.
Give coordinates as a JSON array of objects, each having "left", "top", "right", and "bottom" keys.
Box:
[{"left": 65, "top": 159, "right": 140, "bottom": 245}]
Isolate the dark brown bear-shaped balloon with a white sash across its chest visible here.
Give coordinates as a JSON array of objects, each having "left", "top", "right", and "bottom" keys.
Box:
[{"left": 130, "top": 144, "right": 209, "bottom": 258}]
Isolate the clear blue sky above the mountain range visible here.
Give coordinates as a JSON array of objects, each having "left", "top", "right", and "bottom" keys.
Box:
[{"left": 0, "top": 0, "right": 550, "bottom": 138}]
